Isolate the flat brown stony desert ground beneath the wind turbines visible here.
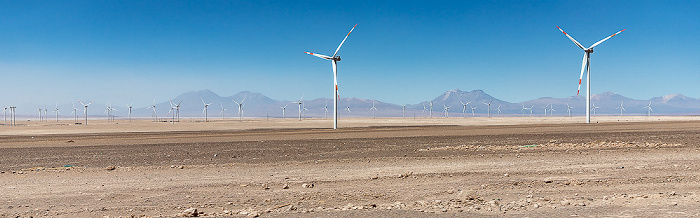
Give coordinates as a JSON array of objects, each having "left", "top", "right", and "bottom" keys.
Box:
[{"left": 0, "top": 116, "right": 700, "bottom": 217}]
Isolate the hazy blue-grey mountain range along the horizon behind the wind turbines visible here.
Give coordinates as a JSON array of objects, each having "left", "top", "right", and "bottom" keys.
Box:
[{"left": 9, "top": 89, "right": 700, "bottom": 119}]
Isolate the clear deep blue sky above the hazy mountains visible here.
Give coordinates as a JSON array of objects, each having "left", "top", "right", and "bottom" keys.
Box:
[{"left": 0, "top": 0, "right": 700, "bottom": 106}]
